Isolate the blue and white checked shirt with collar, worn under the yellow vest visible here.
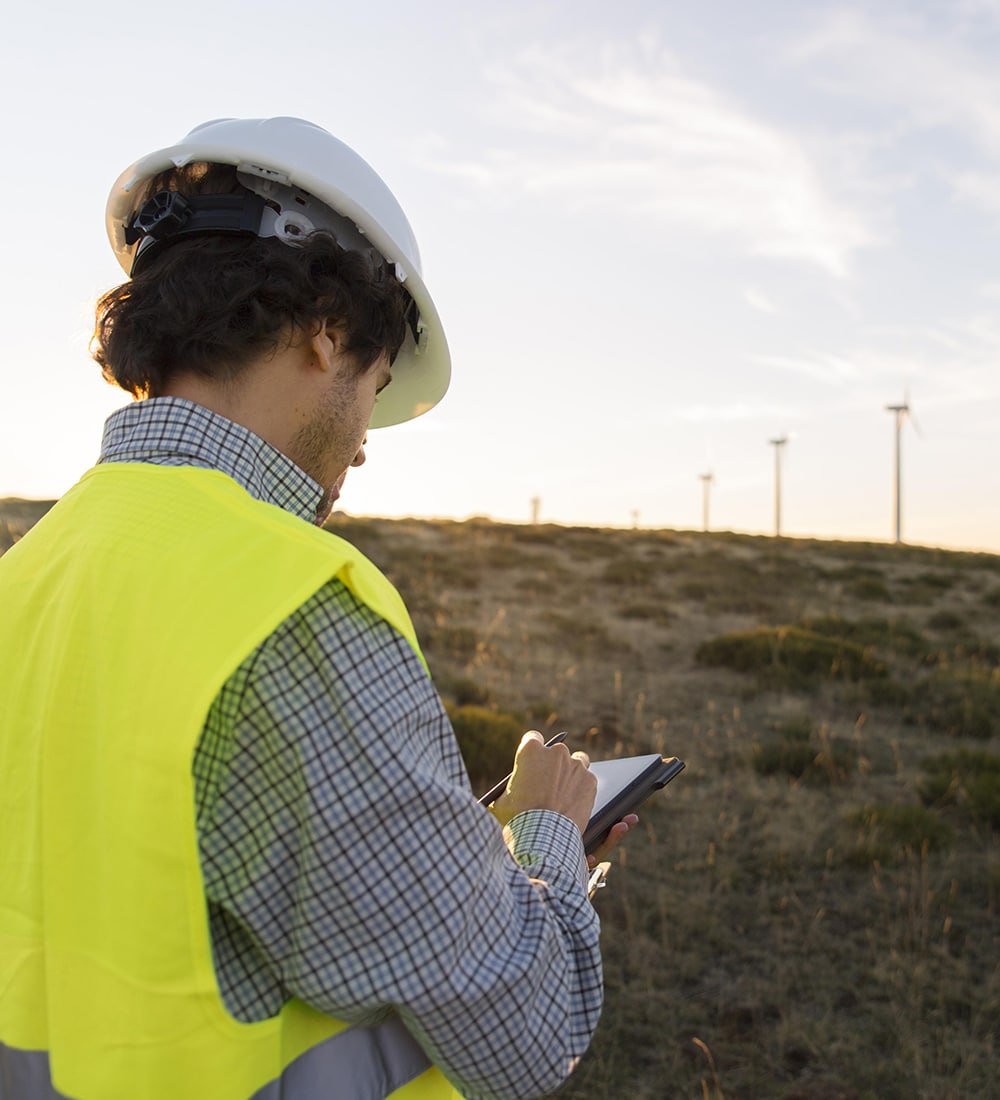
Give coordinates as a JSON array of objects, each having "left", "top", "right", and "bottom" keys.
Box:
[{"left": 100, "top": 398, "right": 603, "bottom": 1097}]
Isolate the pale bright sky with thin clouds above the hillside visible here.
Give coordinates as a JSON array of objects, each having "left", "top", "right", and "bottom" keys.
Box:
[{"left": 0, "top": 0, "right": 1000, "bottom": 552}]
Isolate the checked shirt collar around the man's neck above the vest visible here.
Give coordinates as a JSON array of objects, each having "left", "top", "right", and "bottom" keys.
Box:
[{"left": 98, "top": 397, "right": 323, "bottom": 524}]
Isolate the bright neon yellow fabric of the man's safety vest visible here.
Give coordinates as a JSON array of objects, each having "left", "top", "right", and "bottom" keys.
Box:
[{"left": 0, "top": 464, "right": 458, "bottom": 1100}]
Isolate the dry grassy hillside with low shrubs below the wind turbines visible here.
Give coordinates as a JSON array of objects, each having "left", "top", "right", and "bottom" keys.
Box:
[{"left": 0, "top": 503, "right": 1000, "bottom": 1100}]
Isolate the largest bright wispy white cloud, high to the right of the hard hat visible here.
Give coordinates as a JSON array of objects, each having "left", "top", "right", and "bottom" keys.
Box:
[{"left": 418, "top": 44, "right": 875, "bottom": 276}]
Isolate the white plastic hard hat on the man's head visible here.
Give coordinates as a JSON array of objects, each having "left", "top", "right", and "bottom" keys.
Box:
[{"left": 107, "top": 118, "right": 451, "bottom": 428}]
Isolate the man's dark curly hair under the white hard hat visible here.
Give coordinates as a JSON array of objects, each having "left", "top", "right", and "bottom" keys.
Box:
[{"left": 90, "top": 164, "right": 411, "bottom": 397}]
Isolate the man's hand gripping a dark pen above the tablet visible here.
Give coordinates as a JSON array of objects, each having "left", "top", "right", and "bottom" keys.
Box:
[{"left": 493, "top": 729, "right": 598, "bottom": 835}]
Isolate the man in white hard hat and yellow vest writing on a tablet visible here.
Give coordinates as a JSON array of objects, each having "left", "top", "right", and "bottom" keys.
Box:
[{"left": 0, "top": 119, "right": 634, "bottom": 1100}]
